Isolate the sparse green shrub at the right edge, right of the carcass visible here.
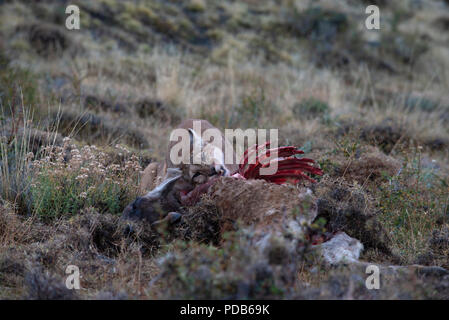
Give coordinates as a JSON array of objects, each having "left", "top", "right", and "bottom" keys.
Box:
[{"left": 377, "top": 150, "right": 448, "bottom": 263}]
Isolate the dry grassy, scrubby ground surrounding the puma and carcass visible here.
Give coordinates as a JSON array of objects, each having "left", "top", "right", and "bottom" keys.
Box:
[{"left": 0, "top": 0, "right": 449, "bottom": 299}]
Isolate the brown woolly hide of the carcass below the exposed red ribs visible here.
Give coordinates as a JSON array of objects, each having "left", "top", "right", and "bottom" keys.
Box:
[{"left": 209, "top": 177, "right": 317, "bottom": 234}]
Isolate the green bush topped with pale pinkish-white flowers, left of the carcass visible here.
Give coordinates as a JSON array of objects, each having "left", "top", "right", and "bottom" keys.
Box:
[{"left": 31, "top": 138, "right": 142, "bottom": 220}]
